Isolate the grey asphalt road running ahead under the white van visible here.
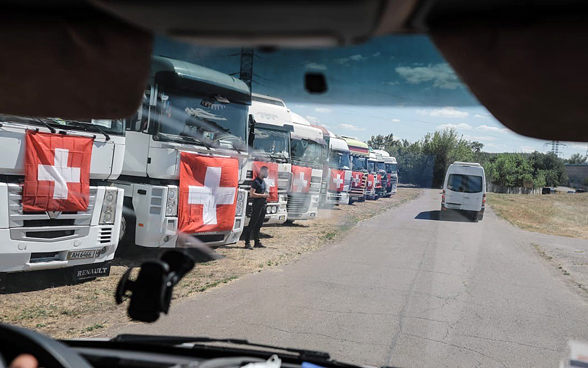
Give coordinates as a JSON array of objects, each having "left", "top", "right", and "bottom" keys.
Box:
[{"left": 111, "top": 190, "right": 588, "bottom": 367}]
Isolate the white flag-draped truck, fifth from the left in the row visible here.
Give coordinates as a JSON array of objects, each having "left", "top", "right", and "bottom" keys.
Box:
[{"left": 313, "top": 125, "right": 351, "bottom": 206}]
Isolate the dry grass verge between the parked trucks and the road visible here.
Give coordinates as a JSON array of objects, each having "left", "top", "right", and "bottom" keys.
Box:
[{"left": 0, "top": 188, "right": 421, "bottom": 338}]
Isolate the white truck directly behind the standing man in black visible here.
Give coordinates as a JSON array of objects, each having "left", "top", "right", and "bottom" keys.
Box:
[{"left": 245, "top": 93, "right": 292, "bottom": 224}]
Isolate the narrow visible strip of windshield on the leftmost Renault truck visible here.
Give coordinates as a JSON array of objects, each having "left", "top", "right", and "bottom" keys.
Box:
[{"left": 0, "top": 115, "right": 125, "bottom": 135}]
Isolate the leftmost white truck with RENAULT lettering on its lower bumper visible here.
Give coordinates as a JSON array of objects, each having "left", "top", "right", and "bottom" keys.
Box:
[{"left": 0, "top": 115, "right": 125, "bottom": 287}]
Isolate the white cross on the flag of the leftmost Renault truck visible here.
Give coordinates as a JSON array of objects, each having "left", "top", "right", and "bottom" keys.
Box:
[{"left": 37, "top": 148, "right": 80, "bottom": 199}]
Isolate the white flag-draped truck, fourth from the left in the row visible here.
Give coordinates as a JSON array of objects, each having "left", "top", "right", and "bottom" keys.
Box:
[{"left": 288, "top": 113, "right": 326, "bottom": 221}]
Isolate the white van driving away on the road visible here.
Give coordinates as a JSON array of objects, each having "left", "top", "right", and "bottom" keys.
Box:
[{"left": 441, "top": 161, "right": 486, "bottom": 221}]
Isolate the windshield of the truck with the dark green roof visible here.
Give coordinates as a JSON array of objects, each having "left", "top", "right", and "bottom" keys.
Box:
[{"left": 157, "top": 93, "right": 247, "bottom": 148}]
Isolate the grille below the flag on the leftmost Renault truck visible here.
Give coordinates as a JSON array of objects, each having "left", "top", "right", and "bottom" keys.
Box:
[{"left": 8, "top": 184, "right": 97, "bottom": 228}]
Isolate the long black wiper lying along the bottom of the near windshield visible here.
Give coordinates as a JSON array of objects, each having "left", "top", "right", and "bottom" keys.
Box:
[{"left": 110, "top": 334, "right": 331, "bottom": 360}]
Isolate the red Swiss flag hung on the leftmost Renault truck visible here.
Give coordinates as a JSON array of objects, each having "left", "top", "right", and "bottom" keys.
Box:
[{"left": 22, "top": 130, "right": 94, "bottom": 212}]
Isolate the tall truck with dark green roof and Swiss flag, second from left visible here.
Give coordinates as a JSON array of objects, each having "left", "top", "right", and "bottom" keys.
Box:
[{"left": 116, "top": 57, "right": 251, "bottom": 247}]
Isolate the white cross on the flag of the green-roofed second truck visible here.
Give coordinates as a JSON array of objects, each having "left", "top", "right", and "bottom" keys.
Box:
[{"left": 188, "top": 167, "right": 237, "bottom": 225}]
